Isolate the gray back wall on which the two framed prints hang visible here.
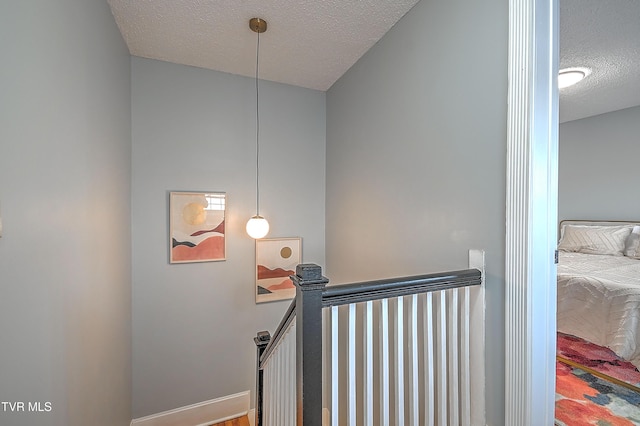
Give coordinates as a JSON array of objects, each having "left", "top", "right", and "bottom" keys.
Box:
[{"left": 132, "top": 58, "right": 326, "bottom": 418}]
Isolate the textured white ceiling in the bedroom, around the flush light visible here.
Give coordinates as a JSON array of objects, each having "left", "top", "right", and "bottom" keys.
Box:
[{"left": 560, "top": 0, "right": 640, "bottom": 122}]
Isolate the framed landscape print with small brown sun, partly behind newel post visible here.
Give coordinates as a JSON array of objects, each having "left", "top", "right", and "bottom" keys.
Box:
[{"left": 256, "top": 238, "right": 302, "bottom": 303}]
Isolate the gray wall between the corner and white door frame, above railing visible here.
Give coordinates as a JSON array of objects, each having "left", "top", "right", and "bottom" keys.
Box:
[{"left": 326, "top": 0, "right": 508, "bottom": 425}]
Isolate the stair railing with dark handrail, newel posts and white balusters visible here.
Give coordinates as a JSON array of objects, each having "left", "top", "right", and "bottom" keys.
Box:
[{"left": 254, "top": 250, "right": 485, "bottom": 426}]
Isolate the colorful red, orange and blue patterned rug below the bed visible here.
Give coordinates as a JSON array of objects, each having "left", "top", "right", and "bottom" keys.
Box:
[{"left": 555, "top": 333, "right": 640, "bottom": 426}]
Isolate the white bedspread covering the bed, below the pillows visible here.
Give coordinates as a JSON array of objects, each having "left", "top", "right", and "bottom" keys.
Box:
[{"left": 557, "top": 252, "right": 640, "bottom": 367}]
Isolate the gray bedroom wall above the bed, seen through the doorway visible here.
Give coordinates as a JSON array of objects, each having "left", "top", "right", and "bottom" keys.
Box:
[{"left": 558, "top": 106, "right": 640, "bottom": 220}]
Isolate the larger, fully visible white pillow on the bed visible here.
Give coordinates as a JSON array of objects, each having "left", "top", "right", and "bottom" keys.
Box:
[{"left": 558, "top": 225, "right": 633, "bottom": 256}]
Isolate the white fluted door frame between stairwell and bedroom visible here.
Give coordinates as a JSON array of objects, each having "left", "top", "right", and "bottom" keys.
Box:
[{"left": 505, "top": 0, "right": 558, "bottom": 426}]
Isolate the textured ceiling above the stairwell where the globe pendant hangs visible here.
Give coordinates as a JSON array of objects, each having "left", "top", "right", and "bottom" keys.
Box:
[{"left": 108, "top": 0, "right": 418, "bottom": 91}]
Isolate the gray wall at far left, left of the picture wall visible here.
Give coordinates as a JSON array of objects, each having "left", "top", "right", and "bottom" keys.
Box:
[{"left": 0, "top": 0, "right": 131, "bottom": 426}]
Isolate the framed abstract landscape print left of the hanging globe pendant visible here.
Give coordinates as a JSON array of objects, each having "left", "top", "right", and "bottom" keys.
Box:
[{"left": 169, "top": 192, "right": 226, "bottom": 263}]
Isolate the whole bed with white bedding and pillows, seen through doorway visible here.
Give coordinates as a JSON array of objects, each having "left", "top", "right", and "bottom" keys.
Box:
[{"left": 557, "top": 221, "right": 640, "bottom": 367}]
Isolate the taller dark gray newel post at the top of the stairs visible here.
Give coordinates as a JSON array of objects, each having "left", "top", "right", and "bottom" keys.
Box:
[{"left": 291, "top": 263, "right": 329, "bottom": 426}]
